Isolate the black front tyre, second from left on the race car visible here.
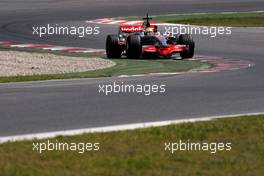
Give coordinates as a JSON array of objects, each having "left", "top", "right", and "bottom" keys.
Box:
[{"left": 126, "top": 35, "right": 142, "bottom": 59}]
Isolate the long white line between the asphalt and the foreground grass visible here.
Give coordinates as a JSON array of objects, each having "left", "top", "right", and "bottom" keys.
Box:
[{"left": 0, "top": 112, "right": 264, "bottom": 144}]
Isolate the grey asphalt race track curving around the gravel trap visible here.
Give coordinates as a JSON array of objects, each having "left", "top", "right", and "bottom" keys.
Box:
[{"left": 0, "top": 0, "right": 264, "bottom": 136}]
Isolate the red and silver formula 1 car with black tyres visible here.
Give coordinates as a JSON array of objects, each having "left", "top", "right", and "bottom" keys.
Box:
[{"left": 106, "top": 14, "right": 195, "bottom": 59}]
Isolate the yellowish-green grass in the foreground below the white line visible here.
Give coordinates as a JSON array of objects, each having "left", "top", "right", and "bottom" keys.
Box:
[{"left": 0, "top": 116, "right": 264, "bottom": 176}]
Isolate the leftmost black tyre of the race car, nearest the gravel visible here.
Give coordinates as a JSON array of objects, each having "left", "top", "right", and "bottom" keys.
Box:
[{"left": 106, "top": 35, "right": 122, "bottom": 58}]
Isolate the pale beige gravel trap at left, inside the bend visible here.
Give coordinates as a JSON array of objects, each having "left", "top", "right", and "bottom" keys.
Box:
[{"left": 0, "top": 51, "right": 115, "bottom": 77}]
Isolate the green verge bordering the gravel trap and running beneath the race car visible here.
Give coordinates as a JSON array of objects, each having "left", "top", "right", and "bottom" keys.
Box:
[{"left": 0, "top": 47, "right": 208, "bottom": 83}]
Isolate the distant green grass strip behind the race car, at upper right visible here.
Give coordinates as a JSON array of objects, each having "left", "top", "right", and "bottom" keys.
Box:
[{"left": 120, "top": 12, "right": 264, "bottom": 27}]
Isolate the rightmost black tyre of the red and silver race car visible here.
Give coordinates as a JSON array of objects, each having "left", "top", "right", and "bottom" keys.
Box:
[{"left": 179, "top": 34, "right": 195, "bottom": 59}]
